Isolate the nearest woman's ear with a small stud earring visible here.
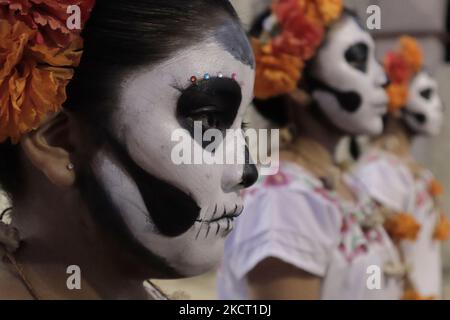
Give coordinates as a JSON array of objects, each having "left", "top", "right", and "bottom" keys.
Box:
[{"left": 20, "top": 112, "right": 75, "bottom": 187}]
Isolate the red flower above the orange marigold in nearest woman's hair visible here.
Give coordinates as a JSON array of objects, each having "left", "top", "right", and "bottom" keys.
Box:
[{"left": 0, "top": 0, "right": 95, "bottom": 48}]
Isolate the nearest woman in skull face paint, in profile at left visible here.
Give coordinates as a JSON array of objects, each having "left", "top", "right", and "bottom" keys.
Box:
[{"left": 0, "top": 0, "right": 257, "bottom": 299}]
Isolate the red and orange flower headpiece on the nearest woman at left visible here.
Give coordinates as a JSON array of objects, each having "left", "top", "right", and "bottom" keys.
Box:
[{"left": 0, "top": 0, "right": 95, "bottom": 143}]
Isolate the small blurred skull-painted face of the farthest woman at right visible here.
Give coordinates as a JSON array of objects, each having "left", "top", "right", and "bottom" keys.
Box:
[{"left": 403, "top": 71, "right": 444, "bottom": 136}]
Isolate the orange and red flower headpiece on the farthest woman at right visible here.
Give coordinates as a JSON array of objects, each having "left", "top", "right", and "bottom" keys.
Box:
[{"left": 384, "top": 36, "right": 423, "bottom": 112}]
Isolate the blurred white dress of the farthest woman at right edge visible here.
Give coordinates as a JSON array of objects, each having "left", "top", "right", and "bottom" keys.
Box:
[{"left": 353, "top": 148, "right": 442, "bottom": 297}]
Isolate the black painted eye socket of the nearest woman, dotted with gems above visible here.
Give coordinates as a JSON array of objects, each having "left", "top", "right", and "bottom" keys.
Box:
[{"left": 176, "top": 78, "right": 242, "bottom": 136}]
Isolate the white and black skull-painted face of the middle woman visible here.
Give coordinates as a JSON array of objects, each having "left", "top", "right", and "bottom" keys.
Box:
[{"left": 308, "top": 17, "right": 388, "bottom": 135}]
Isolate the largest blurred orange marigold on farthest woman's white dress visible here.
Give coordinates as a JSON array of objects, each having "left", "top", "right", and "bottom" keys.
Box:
[{"left": 384, "top": 213, "right": 420, "bottom": 241}]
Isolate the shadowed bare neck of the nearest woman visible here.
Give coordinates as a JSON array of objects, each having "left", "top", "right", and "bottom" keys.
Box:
[{"left": 9, "top": 170, "right": 150, "bottom": 299}]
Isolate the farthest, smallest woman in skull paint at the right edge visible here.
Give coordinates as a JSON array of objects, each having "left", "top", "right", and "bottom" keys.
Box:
[{"left": 354, "top": 36, "right": 450, "bottom": 299}]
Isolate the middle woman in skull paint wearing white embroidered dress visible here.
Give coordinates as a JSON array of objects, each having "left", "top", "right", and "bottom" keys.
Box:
[{"left": 219, "top": 0, "right": 402, "bottom": 299}]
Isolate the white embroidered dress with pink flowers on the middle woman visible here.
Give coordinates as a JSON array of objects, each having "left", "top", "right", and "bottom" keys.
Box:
[{"left": 218, "top": 162, "right": 402, "bottom": 299}]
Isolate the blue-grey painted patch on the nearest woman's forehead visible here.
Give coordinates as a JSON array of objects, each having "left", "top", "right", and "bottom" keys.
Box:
[{"left": 214, "top": 20, "right": 255, "bottom": 69}]
